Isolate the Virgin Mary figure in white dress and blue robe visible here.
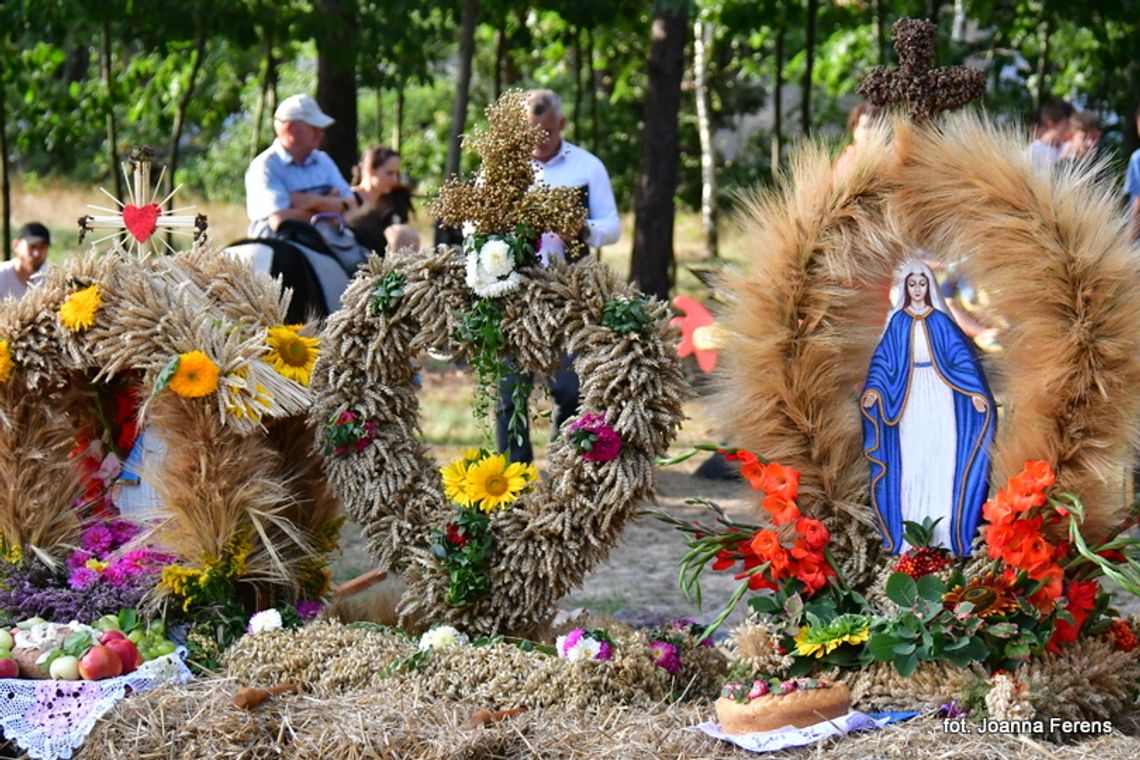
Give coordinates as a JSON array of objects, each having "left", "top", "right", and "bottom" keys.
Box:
[{"left": 860, "top": 261, "right": 996, "bottom": 556}]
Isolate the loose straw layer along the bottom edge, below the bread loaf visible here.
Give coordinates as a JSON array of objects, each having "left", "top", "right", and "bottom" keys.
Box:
[{"left": 76, "top": 679, "right": 1140, "bottom": 760}]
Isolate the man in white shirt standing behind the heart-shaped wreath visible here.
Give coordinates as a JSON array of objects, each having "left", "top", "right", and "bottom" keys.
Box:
[{"left": 495, "top": 90, "right": 621, "bottom": 461}]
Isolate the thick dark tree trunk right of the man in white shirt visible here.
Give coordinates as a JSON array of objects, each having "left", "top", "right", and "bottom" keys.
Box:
[{"left": 629, "top": 9, "right": 689, "bottom": 300}]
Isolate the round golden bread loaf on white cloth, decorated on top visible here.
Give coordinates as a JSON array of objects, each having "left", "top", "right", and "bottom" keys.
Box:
[{"left": 716, "top": 679, "right": 850, "bottom": 735}]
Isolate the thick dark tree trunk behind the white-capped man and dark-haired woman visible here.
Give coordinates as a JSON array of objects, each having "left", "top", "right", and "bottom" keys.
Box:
[{"left": 317, "top": 0, "right": 360, "bottom": 178}]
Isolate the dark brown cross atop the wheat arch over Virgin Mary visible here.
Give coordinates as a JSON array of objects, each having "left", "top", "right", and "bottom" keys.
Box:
[{"left": 858, "top": 18, "right": 986, "bottom": 121}]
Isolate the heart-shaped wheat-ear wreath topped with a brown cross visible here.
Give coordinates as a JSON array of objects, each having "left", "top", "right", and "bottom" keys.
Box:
[{"left": 312, "top": 93, "right": 685, "bottom": 634}]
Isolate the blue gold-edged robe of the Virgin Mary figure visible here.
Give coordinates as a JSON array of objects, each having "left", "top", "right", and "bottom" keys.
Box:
[{"left": 860, "top": 309, "right": 996, "bottom": 556}]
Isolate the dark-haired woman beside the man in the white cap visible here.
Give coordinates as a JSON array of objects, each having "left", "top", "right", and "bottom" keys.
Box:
[{"left": 345, "top": 145, "right": 415, "bottom": 255}]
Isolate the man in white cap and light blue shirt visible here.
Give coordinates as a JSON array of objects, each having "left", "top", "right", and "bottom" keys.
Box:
[{"left": 245, "top": 95, "right": 357, "bottom": 237}]
